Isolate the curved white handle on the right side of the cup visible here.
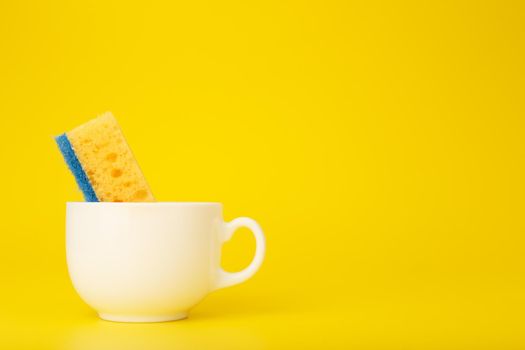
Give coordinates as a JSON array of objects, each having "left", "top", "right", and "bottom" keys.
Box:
[{"left": 213, "top": 217, "right": 266, "bottom": 290}]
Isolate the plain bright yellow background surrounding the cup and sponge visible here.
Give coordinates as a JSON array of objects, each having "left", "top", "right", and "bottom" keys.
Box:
[{"left": 0, "top": 0, "right": 525, "bottom": 349}]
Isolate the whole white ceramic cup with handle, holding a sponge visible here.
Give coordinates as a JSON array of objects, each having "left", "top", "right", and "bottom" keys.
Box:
[{"left": 66, "top": 202, "right": 265, "bottom": 322}]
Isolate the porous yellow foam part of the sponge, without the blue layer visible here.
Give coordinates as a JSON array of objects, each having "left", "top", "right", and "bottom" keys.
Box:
[{"left": 67, "top": 112, "right": 155, "bottom": 202}]
